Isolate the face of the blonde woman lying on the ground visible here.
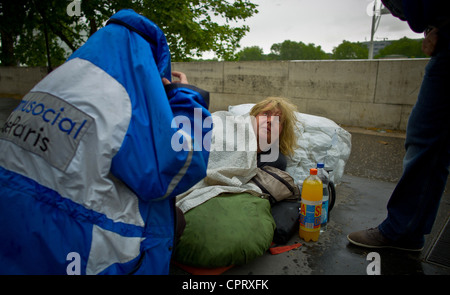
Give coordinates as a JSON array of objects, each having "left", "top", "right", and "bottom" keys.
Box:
[{"left": 255, "top": 108, "right": 283, "bottom": 151}]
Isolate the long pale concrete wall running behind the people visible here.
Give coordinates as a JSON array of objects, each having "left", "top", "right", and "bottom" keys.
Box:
[{"left": 0, "top": 59, "right": 428, "bottom": 130}]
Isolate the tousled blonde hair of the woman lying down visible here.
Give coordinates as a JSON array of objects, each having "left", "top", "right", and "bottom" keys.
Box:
[{"left": 250, "top": 97, "right": 298, "bottom": 156}]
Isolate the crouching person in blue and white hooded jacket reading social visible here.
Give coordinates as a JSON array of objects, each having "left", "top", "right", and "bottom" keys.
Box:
[{"left": 0, "top": 10, "right": 210, "bottom": 274}]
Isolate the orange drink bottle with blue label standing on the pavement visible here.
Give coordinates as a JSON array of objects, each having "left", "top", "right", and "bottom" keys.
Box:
[{"left": 299, "top": 168, "right": 323, "bottom": 242}]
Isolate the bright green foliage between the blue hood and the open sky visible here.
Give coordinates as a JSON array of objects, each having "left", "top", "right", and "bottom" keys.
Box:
[{"left": 140, "top": 0, "right": 258, "bottom": 61}]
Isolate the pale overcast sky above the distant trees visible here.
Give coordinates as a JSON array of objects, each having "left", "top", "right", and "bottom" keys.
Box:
[{"left": 223, "top": 0, "right": 423, "bottom": 54}]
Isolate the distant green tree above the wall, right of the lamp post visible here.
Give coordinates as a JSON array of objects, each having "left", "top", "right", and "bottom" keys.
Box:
[{"left": 374, "top": 37, "right": 427, "bottom": 58}]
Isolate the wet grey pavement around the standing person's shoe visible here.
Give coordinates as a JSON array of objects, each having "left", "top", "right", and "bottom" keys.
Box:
[{"left": 219, "top": 175, "right": 450, "bottom": 275}]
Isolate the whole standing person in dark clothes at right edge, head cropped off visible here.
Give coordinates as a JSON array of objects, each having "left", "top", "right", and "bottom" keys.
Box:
[{"left": 347, "top": 0, "right": 450, "bottom": 251}]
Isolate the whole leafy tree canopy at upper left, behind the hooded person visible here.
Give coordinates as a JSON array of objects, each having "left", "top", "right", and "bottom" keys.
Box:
[{"left": 0, "top": 0, "right": 258, "bottom": 68}]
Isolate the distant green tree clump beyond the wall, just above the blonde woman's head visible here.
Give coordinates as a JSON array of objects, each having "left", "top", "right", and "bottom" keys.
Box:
[{"left": 270, "top": 40, "right": 328, "bottom": 60}]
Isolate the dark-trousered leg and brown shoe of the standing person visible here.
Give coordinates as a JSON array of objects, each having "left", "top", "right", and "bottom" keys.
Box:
[{"left": 348, "top": 50, "right": 450, "bottom": 250}]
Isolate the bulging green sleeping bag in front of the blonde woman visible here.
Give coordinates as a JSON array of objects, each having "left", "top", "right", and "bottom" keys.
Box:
[{"left": 174, "top": 193, "right": 275, "bottom": 268}]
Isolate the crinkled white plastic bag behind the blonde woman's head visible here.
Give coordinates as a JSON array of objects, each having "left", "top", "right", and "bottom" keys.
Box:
[{"left": 228, "top": 104, "right": 352, "bottom": 186}]
